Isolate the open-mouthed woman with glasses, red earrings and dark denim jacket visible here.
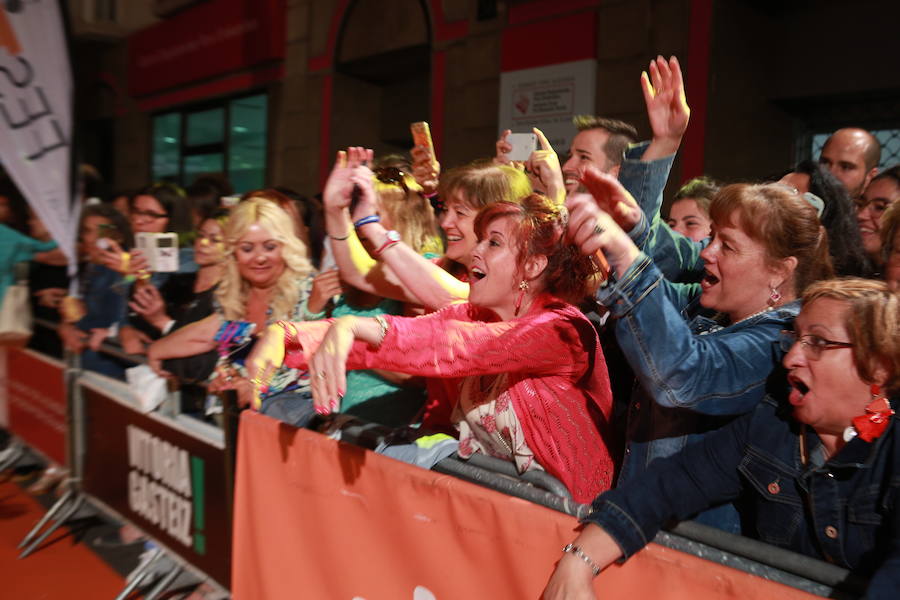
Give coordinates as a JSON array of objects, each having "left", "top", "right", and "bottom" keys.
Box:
[{"left": 544, "top": 279, "right": 900, "bottom": 600}]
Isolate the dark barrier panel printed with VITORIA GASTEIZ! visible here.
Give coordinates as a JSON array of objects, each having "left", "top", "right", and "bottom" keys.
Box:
[{"left": 81, "top": 383, "right": 231, "bottom": 587}]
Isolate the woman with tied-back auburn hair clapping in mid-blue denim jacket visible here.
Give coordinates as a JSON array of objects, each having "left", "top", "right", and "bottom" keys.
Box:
[{"left": 568, "top": 170, "right": 832, "bottom": 533}]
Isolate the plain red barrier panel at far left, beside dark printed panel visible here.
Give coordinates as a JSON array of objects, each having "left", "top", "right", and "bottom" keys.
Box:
[{"left": 0, "top": 348, "right": 67, "bottom": 465}]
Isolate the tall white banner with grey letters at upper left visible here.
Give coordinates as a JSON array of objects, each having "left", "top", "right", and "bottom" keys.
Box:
[{"left": 0, "top": 0, "right": 79, "bottom": 270}]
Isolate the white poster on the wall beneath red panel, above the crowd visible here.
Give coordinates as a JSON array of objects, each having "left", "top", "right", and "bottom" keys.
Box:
[{"left": 498, "top": 59, "right": 597, "bottom": 157}]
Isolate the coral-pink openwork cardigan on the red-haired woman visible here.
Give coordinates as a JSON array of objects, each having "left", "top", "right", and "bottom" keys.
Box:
[{"left": 285, "top": 296, "right": 613, "bottom": 503}]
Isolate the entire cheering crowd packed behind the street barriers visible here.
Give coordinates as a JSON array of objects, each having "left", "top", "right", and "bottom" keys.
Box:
[{"left": 0, "top": 57, "right": 900, "bottom": 599}]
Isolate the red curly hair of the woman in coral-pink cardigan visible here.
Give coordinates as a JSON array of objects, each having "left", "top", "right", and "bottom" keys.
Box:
[{"left": 475, "top": 194, "right": 597, "bottom": 303}]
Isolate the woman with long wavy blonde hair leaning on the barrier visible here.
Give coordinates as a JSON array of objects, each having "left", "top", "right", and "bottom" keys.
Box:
[{"left": 148, "top": 196, "right": 321, "bottom": 421}]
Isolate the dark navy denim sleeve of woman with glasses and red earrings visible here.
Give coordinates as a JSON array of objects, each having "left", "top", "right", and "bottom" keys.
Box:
[{"left": 582, "top": 406, "right": 753, "bottom": 560}]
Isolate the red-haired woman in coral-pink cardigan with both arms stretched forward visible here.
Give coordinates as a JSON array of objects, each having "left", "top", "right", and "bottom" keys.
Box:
[{"left": 250, "top": 194, "right": 613, "bottom": 502}]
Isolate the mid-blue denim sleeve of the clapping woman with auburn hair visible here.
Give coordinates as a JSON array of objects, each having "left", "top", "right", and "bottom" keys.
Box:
[{"left": 597, "top": 254, "right": 789, "bottom": 415}]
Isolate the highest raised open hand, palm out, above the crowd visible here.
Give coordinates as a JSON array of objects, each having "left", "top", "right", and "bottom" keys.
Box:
[{"left": 641, "top": 56, "right": 691, "bottom": 160}]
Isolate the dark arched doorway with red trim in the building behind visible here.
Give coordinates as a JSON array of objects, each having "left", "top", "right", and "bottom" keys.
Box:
[{"left": 330, "top": 0, "right": 432, "bottom": 154}]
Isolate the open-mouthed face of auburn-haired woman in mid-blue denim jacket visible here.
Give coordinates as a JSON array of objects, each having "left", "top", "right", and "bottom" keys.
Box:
[{"left": 700, "top": 215, "right": 785, "bottom": 322}]
